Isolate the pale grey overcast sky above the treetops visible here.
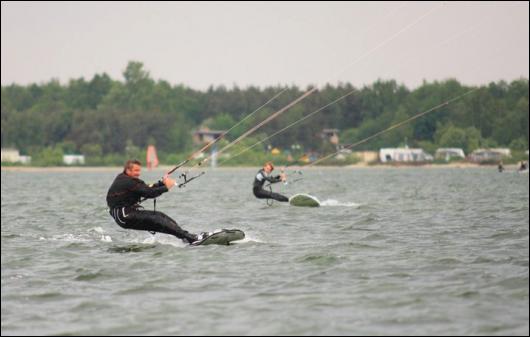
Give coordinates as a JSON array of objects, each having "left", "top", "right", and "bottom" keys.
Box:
[{"left": 1, "top": 1, "right": 529, "bottom": 89}]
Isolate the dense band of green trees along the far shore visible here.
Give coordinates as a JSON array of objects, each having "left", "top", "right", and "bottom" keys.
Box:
[{"left": 1, "top": 61, "right": 529, "bottom": 164}]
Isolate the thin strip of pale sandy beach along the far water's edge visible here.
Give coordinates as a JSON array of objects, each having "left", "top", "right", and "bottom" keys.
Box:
[{"left": 1, "top": 163, "right": 518, "bottom": 172}]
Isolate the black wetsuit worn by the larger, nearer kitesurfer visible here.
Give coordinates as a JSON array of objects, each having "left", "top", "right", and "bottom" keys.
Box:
[{"left": 107, "top": 173, "right": 197, "bottom": 243}]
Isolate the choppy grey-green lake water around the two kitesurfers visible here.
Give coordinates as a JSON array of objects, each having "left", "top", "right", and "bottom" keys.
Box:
[{"left": 1, "top": 168, "right": 529, "bottom": 336}]
